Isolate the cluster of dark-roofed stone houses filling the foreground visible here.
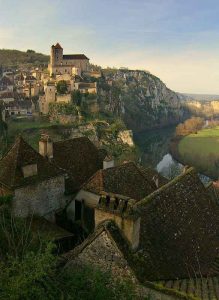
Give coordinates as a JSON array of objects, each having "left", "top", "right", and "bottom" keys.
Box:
[{"left": 0, "top": 135, "right": 219, "bottom": 299}]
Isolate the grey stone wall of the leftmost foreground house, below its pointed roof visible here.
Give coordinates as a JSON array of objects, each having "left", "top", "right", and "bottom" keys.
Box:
[{"left": 12, "top": 176, "right": 66, "bottom": 220}]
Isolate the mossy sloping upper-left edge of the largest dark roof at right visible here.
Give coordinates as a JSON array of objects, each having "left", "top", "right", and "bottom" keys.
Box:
[{"left": 134, "top": 167, "right": 196, "bottom": 208}]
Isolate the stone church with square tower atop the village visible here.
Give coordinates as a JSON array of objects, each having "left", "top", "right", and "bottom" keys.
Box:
[{"left": 48, "top": 43, "right": 89, "bottom": 75}]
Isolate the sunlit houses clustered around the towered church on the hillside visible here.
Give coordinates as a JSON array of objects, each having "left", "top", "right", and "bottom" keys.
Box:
[{"left": 0, "top": 43, "right": 101, "bottom": 119}]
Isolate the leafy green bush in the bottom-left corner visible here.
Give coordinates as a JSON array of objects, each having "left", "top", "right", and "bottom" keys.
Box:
[{"left": 0, "top": 244, "right": 55, "bottom": 300}]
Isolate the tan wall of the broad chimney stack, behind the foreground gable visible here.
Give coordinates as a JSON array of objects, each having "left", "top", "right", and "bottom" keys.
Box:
[{"left": 95, "top": 209, "right": 140, "bottom": 250}]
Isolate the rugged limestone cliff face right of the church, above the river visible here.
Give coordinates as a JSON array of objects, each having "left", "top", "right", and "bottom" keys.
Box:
[{"left": 98, "top": 69, "right": 188, "bottom": 132}]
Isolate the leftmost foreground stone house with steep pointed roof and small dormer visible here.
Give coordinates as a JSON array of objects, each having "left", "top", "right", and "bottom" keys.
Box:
[{"left": 0, "top": 137, "right": 66, "bottom": 221}]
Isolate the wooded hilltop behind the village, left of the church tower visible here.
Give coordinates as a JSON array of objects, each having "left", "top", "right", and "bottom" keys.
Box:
[{"left": 0, "top": 49, "right": 49, "bottom": 67}]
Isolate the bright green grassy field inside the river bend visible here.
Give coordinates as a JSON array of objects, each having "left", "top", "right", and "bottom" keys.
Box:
[{"left": 170, "top": 126, "right": 219, "bottom": 180}]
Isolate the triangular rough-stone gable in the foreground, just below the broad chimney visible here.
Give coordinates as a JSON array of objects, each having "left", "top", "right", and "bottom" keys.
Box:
[{"left": 62, "top": 221, "right": 136, "bottom": 282}]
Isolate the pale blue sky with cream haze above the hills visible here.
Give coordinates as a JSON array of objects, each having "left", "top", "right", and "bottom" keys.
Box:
[{"left": 0, "top": 0, "right": 219, "bottom": 94}]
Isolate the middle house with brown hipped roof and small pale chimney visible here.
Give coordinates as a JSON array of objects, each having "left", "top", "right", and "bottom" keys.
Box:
[{"left": 67, "top": 162, "right": 167, "bottom": 231}]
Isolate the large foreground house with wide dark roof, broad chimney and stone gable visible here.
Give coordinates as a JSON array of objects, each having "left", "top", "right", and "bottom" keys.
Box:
[{"left": 63, "top": 168, "right": 219, "bottom": 300}]
